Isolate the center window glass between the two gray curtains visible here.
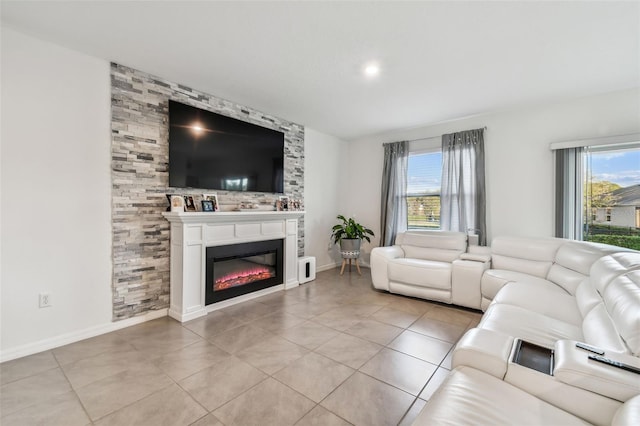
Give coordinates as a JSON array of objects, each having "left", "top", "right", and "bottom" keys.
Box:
[{"left": 407, "top": 151, "right": 442, "bottom": 229}]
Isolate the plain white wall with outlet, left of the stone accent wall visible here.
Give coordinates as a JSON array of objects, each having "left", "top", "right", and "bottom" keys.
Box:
[{"left": 0, "top": 28, "right": 111, "bottom": 359}]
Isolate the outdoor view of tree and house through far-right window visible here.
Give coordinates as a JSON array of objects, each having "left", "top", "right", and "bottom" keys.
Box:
[{"left": 583, "top": 145, "right": 640, "bottom": 250}]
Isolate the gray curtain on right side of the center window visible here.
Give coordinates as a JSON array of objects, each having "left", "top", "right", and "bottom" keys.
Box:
[{"left": 440, "top": 129, "right": 487, "bottom": 245}]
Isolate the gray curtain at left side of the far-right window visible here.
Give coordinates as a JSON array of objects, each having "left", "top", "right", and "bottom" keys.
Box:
[{"left": 555, "top": 147, "right": 584, "bottom": 240}]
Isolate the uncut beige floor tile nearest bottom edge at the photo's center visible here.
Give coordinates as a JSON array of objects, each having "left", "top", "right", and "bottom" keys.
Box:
[{"left": 273, "top": 352, "right": 355, "bottom": 402}]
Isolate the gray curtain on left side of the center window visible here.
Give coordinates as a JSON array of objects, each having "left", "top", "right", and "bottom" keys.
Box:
[{"left": 380, "top": 141, "right": 409, "bottom": 246}]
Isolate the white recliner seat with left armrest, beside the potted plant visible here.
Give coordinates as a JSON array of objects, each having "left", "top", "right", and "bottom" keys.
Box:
[{"left": 371, "top": 231, "right": 467, "bottom": 303}]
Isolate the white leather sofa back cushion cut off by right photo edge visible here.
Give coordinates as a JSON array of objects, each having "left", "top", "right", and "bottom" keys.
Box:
[{"left": 602, "top": 270, "right": 640, "bottom": 356}]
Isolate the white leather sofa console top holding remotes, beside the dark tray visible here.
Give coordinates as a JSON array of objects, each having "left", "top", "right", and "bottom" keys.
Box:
[{"left": 553, "top": 340, "right": 640, "bottom": 402}]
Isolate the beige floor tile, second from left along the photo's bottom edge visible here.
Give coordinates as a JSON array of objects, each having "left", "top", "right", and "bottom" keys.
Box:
[{"left": 95, "top": 384, "right": 207, "bottom": 426}]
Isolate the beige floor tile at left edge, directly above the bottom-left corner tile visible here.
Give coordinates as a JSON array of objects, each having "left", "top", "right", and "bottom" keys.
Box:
[{"left": 0, "top": 368, "right": 72, "bottom": 417}]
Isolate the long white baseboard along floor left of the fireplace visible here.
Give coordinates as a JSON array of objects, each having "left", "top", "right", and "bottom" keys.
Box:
[{"left": 0, "top": 308, "right": 169, "bottom": 362}]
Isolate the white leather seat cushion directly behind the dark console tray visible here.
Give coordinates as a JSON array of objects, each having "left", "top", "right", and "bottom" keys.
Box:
[{"left": 478, "top": 303, "right": 584, "bottom": 348}]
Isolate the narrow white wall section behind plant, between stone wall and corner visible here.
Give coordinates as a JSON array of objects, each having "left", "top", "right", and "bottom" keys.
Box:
[{"left": 304, "top": 127, "right": 348, "bottom": 270}]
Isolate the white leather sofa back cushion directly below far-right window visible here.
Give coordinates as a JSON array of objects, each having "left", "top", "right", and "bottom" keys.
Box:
[{"left": 547, "top": 241, "right": 621, "bottom": 294}]
